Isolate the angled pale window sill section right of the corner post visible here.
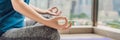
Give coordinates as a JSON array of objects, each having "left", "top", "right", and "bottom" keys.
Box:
[{"left": 94, "top": 26, "right": 120, "bottom": 40}]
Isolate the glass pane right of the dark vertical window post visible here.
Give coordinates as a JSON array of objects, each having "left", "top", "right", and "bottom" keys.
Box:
[{"left": 98, "top": 0, "right": 120, "bottom": 29}]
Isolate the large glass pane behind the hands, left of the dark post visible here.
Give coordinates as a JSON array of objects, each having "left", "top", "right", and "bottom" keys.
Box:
[{"left": 31, "top": 0, "right": 92, "bottom": 26}]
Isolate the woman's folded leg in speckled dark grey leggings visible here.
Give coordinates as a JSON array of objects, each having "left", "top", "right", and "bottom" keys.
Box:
[{"left": 2, "top": 25, "right": 60, "bottom": 40}]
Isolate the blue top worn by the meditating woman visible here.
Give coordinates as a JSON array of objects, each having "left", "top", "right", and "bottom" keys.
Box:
[{"left": 0, "top": 0, "right": 29, "bottom": 36}]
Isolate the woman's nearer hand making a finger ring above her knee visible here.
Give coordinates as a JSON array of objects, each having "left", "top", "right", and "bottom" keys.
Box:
[{"left": 47, "top": 17, "right": 72, "bottom": 30}]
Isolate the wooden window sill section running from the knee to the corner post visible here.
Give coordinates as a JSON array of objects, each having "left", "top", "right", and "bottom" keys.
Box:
[{"left": 59, "top": 26, "right": 93, "bottom": 34}]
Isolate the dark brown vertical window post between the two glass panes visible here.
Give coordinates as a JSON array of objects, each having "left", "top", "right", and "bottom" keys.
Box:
[{"left": 92, "top": 0, "right": 99, "bottom": 27}]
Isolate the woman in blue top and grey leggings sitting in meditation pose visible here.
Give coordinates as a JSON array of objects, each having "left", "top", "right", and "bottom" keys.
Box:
[{"left": 0, "top": 0, "right": 71, "bottom": 40}]
